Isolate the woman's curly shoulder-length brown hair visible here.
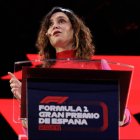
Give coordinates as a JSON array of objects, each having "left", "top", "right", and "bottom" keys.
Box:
[{"left": 36, "top": 7, "right": 95, "bottom": 67}]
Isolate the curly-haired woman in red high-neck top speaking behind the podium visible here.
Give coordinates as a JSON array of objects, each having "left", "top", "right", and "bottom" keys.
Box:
[{"left": 8, "top": 7, "right": 130, "bottom": 127}]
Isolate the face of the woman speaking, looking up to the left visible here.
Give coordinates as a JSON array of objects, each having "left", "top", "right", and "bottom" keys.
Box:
[{"left": 46, "top": 12, "right": 73, "bottom": 52}]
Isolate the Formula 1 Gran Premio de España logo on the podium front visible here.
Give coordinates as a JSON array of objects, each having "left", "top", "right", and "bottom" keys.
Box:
[{"left": 38, "top": 96, "right": 108, "bottom": 131}]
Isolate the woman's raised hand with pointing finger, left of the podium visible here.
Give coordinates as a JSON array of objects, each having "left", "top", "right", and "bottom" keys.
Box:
[{"left": 8, "top": 72, "right": 22, "bottom": 100}]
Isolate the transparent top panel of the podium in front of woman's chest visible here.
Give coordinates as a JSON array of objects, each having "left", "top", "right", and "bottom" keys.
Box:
[{"left": 14, "top": 58, "right": 134, "bottom": 71}]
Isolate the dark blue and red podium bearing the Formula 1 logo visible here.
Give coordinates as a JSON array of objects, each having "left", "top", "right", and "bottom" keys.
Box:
[{"left": 12, "top": 60, "right": 133, "bottom": 140}]
